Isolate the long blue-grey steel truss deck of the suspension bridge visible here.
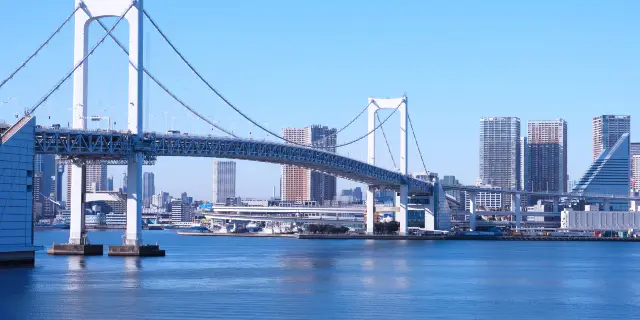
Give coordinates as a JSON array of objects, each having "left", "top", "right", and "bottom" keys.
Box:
[{"left": 35, "top": 126, "right": 433, "bottom": 194}]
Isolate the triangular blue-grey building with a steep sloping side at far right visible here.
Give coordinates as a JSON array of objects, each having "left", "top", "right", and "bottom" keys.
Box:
[{"left": 573, "top": 133, "right": 631, "bottom": 211}]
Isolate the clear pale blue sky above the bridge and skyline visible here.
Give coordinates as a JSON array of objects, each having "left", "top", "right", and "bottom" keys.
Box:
[{"left": 0, "top": 0, "right": 640, "bottom": 199}]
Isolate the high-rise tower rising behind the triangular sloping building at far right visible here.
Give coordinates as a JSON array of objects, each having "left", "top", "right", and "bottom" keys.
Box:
[{"left": 593, "top": 115, "right": 631, "bottom": 160}]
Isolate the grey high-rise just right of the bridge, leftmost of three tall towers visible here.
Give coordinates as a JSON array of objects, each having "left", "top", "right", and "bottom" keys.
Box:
[{"left": 480, "top": 117, "right": 521, "bottom": 192}]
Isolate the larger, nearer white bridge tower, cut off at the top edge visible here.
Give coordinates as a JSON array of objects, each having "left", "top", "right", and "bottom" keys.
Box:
[{"left": 69, "top": 0, "right": 144, "bottom": 246}]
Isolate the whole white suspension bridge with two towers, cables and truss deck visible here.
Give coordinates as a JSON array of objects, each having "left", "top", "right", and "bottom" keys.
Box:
[{"left": 0, "top": 0, "right": 433, "bottom": 252}]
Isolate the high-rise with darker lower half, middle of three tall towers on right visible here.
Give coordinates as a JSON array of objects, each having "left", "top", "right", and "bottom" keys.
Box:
[{"left": 525, "top": 119, "right": 568, "bottom": 202}]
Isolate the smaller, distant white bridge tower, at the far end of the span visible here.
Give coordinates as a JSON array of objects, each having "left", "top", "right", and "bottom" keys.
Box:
[{"left": 367, "top": 95, "right": 409, "bottom": 235}]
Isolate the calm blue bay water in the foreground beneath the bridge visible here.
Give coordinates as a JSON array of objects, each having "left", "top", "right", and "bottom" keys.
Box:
[{"left": 0, "top": 230, "right": 640, "bottom": 320}]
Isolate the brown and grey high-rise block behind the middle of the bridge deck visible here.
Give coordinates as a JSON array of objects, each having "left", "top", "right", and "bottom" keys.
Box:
[{"left": 280, "top": 125, "right": 337, "bottom": 202}]
